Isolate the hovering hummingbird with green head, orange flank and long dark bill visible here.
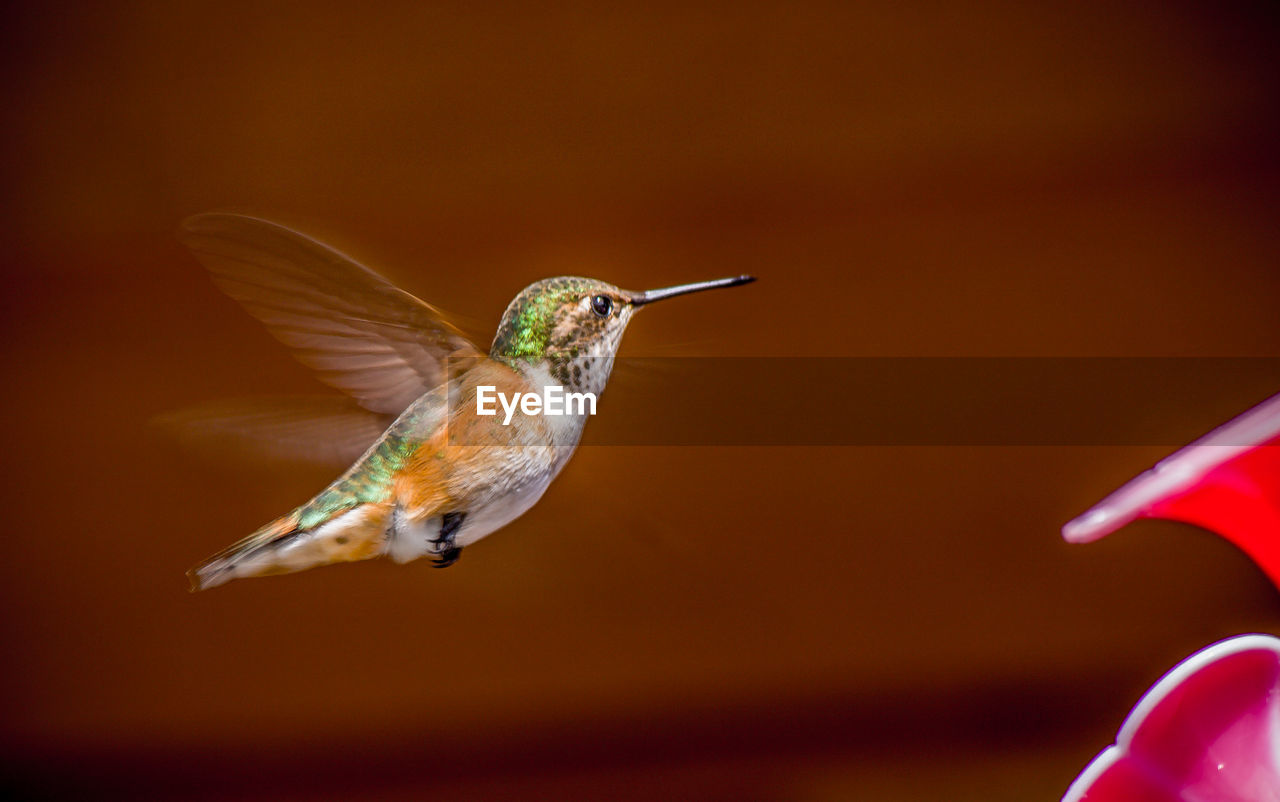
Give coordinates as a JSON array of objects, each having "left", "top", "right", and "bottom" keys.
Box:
[{"left": 179, "top": 212, "right": 755, "bottom": 591}]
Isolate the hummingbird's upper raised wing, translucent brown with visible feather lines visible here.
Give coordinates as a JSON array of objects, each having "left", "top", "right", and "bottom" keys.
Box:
[{"left": 179, "top": 214, "right": 479, "bottom": 414}]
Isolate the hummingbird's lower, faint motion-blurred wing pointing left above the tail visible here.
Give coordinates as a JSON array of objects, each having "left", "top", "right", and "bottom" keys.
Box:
[{"left": 154, "top": 395, "right": 392, "bottom": 469}]
